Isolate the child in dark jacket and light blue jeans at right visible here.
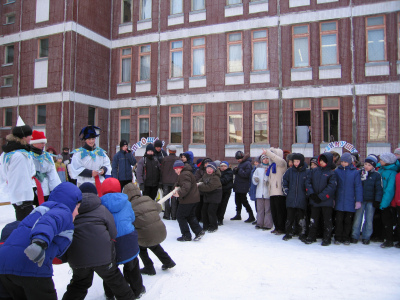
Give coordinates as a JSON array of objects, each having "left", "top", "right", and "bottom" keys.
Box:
[{"left": 351, "top": 156, "right": 383, "bottom": 245}]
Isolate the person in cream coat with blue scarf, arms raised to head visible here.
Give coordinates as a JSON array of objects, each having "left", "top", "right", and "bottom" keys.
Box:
[{"left": 263, "top": 148, "right": 287, "bottom": 235}]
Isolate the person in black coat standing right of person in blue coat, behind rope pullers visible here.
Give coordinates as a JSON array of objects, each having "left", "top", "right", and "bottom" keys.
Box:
[{"left": 136, "top": 144, "right": 162, "bottom": 200}]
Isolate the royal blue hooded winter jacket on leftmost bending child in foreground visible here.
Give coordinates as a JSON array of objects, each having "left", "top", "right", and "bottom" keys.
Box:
[{"left": 0, "top": 182, "right": 82, "bottom": 277}]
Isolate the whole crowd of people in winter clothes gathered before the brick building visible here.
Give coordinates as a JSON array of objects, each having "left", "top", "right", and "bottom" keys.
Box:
[{"left": 0, "top": 118, "right": 400, "bottom": 300}]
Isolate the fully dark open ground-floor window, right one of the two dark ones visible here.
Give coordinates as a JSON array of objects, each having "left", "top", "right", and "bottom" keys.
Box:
[{"left": 321, "top": 98, "right": 339, "bottom": 143}]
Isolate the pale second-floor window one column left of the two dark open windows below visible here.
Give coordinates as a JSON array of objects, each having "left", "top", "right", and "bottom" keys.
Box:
[{"left": 251, "top": 29, "right": 268, "bottom": 71}]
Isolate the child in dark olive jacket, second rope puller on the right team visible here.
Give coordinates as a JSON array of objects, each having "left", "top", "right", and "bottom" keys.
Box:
[{"left": 198, "top": 162, "right": 222, "bottom": 233}]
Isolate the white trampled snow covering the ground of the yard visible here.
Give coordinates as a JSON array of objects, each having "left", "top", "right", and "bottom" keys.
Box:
[{"left": 0, "top": 193, "right": 400, "bottom": 300}]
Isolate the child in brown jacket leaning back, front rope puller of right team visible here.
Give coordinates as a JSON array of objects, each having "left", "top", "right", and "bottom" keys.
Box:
[{"left": 173, "top": 160, "right": 204, "bottom": 242}]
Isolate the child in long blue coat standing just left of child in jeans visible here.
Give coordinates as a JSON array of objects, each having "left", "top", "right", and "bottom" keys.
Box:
[{"left": 335, "top": 152, "right": 363, "bottom": 245}]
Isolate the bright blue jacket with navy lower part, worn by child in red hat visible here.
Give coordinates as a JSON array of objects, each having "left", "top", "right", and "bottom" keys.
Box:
[{"left": 101, "top": 193, "right": 140, "bottom": 264}]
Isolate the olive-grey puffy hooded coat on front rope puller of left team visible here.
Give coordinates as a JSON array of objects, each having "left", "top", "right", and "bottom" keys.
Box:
[{"left": 124, "top": 183, "right": 167, "bottom": 247}]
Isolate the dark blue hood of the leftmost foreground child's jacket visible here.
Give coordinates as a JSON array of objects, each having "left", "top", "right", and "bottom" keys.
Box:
[{"left": 48, "top": 182, "right": 82, "bottom": 213}]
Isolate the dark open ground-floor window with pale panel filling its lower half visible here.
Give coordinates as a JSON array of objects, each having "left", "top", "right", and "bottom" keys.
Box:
[{"left": 293, "top": 99, "right": 311, "bottom": 144}]
